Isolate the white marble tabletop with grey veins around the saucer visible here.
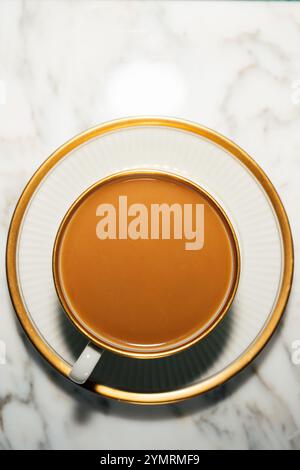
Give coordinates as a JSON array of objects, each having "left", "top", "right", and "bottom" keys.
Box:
[{"left": 0, "top": 0, "right": 300, "bottom": 449}]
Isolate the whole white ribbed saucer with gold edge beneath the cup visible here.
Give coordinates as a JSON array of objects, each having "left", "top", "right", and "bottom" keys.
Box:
[{"left": 7, "top": 117, "right": 293, "bottom": 404}]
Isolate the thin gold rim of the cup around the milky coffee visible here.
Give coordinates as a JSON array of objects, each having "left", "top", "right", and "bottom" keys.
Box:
[{"left": 52, "top": 169, "right": 241, "bottom": 359}]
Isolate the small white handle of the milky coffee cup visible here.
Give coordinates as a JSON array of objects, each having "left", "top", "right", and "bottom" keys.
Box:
[{"left": 69, "top": 343, "right": 103, "bottom": 385}]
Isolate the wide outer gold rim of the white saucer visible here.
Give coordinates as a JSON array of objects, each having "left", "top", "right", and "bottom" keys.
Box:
[{"left": 6, "top": 117, "right": 294, "bottom": 405}]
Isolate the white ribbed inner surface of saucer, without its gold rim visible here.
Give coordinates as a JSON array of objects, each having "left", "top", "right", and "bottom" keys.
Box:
[{"left": 7, "top": 120, "right": 292, "bottom": 401}]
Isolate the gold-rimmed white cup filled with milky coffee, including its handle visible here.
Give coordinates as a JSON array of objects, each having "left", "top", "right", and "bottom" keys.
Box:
[{"left": 53, "top": 170, "right": 240, "bottom": 384}]
